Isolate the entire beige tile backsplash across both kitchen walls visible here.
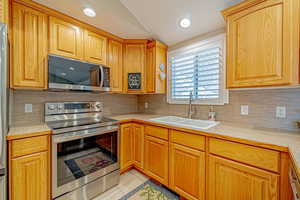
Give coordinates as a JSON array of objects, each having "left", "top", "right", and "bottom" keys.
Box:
[{"left": 10, "top": 88, "right": 300, "bottom": 132}]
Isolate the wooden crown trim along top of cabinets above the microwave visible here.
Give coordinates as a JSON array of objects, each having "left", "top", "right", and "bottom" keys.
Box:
[{"left": 13, "top": 0, "right": 124, "bottom": 42}]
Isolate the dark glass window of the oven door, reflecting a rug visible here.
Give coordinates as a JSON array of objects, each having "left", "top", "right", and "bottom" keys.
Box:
[{"left": 57, "top": 132, "right": 118, "bottom": 187}]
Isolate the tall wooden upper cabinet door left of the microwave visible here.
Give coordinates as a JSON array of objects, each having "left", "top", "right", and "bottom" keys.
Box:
[{"left": 10, "top": 3, "right": 47, "bottom": 89}]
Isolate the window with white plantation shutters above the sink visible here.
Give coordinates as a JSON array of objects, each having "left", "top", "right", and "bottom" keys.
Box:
[{"left": 167, "top": 34, "right": 228, "bottom": 105}]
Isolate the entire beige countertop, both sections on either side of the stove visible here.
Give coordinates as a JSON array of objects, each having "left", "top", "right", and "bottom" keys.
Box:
[{"left": 7, "top": 114, "right": 300, "bottom": 177}]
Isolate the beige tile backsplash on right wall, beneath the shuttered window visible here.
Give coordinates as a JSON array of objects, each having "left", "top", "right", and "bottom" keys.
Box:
[{"left": 138, "top": 88, "right": 300, "bottom": 131}]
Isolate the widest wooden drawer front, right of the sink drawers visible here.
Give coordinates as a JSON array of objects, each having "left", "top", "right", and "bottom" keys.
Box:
[{"left": 209, "top": 138, "right": 280, "bottom": 172}]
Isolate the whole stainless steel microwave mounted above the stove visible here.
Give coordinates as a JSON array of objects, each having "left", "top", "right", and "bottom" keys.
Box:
[{"left": 48, "top": 55, "right": 110, "bottom": 92}]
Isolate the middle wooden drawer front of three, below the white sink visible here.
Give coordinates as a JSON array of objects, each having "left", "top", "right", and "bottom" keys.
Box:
[{"left": 170, "top": 130, "right": 205, "bottom": 150}]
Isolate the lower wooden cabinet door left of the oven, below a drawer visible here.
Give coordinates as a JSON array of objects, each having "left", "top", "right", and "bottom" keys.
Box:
[{"left": 11, "top": 152, "right": 50, "bottom": 200}]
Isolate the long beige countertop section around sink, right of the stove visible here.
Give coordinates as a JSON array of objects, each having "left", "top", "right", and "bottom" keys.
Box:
[{"left": 111, "top": 114, "right": 300, "bottom": 177}]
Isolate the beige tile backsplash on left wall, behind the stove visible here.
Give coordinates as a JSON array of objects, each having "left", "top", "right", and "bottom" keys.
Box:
[{"left": 10, "top": 90, "right": 138, "bottom": 126}]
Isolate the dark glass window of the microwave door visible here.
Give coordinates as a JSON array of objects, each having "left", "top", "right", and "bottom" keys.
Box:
[{"left": 48, "top": 56, "right": 101, "bottom": 87}]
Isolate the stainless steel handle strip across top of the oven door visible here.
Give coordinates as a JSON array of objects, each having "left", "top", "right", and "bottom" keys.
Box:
[{"left": 52, "top": 125, "right": 119, "bottom": 144}]
